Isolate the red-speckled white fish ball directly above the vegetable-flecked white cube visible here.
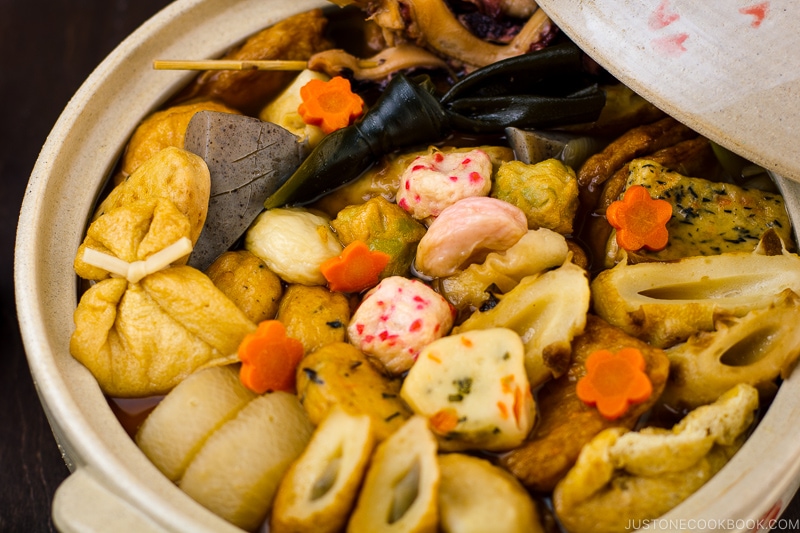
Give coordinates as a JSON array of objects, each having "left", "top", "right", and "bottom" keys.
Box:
[{"left": 347, "top": 276, "right": 455, "bottom": 375}]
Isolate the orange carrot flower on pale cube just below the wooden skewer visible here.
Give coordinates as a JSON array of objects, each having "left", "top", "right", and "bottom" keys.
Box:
[{"left": 297, "top": 76, "right": 364, "bottom": 133}]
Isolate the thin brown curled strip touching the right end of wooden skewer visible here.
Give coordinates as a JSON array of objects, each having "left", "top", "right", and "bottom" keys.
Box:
[{"left": 308, "top": 43, "right": 450, "bottom": 81}]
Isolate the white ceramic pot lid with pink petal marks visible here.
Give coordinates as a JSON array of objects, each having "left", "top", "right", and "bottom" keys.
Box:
[{"left": 539, "top": 0, "right": 800, "bottom": 181}]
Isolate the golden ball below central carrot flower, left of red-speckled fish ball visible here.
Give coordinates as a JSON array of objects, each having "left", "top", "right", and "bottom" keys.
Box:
[{"left": 277, "top": 285, "right": 350, "bottom": 353}]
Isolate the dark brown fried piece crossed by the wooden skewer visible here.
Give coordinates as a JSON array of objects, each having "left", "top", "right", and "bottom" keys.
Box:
[{"left": 177, "top": 9, "right": 331, "bottom": 116}]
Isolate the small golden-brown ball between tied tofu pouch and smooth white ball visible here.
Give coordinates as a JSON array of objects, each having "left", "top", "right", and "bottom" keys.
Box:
[{"left": 206, "top": 250, "right": 283, "bottom": 323}]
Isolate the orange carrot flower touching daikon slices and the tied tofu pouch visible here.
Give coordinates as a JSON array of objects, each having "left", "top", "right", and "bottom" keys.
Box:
[{"left": 238, "top": 320, "right": 303, "bottom": 394}]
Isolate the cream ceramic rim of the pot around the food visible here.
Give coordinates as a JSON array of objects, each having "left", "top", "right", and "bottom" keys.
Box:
[{"left": 14, "top": 0, "right": 800, "bottom": 531}]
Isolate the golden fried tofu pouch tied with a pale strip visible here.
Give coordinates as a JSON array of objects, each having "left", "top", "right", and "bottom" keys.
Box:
[{"left": 70, "top": 198, "right": 255, "bottom": 397}]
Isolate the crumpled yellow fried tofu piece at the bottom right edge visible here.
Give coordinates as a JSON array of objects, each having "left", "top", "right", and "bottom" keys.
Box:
[{"left": 553, "top": 384, "right": 758, "bottom": 533}]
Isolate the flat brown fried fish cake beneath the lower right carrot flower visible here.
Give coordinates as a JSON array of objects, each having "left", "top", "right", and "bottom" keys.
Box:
[{"left": 500, "top": 315, "right": 669, "bottom": 492}]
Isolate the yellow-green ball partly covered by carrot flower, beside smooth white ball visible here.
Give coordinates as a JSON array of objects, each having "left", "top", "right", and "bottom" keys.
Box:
[{"left": 331, "top": 196, "right": 425, "bottom": 279}]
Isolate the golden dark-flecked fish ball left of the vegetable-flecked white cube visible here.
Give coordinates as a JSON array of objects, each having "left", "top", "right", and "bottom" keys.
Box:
[{"left": 297, "top": 342, "right": 411, "bottom": 440}]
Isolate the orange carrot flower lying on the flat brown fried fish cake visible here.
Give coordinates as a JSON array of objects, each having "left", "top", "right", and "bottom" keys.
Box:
[{"left": 576, "top": 348, "right": 653, "bottom": 420}]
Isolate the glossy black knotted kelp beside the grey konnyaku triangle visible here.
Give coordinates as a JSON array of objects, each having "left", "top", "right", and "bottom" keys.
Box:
[{"left": 264, "top": 44, "right": 605, "bottom": 209}]
